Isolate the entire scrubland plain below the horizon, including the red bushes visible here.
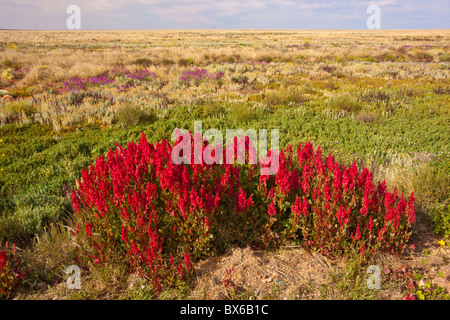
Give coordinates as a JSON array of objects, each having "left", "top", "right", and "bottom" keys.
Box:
[{"left": 0, "top": 30, "right": 450, "bottom": 299}]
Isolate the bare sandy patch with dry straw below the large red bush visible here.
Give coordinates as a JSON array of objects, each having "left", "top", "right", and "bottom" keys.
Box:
[{"left": 190, "top": 248, "right": 338, "bottom": 300}]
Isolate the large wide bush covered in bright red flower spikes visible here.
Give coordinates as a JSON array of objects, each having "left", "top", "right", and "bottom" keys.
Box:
[{"left": 72, "top": 134, "right": 414, "bottom": 289}]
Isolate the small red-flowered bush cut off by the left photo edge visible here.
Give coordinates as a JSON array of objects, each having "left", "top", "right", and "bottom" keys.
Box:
[{"left": 0, "top": 243, "right": 24, "bottom": 299}]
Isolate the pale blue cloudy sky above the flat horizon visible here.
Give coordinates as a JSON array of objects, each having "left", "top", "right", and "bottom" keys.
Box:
[{"left": 0, "top": 0, "right": 450, "bottom": 30}]
